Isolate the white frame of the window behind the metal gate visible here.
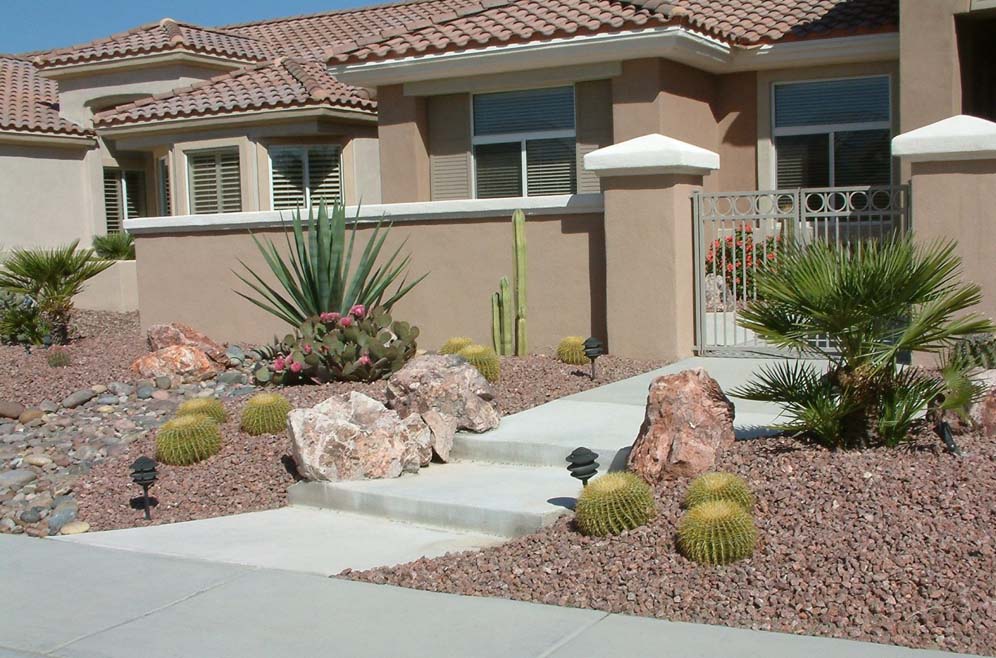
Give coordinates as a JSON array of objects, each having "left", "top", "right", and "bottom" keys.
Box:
[{"left": 768, "top": 73, "right": 896, "bottom": 189}]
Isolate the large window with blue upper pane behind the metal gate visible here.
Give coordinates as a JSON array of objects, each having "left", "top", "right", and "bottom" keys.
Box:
[{"left": 773, "top": 76, "right": 892, "bottom": 188}]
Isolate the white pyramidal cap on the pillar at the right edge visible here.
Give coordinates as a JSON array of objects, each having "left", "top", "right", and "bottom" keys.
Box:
[{"left": 892, "top": 114, "right": 996, "bottom": 162}]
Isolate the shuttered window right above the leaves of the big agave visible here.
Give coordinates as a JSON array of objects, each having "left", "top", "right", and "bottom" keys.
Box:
[{"left": 269, "top": 145, "right": 342, "bottom": 210}]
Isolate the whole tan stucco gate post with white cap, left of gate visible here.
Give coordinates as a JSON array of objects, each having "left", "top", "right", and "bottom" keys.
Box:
[{"left": 584, "top": 134, "right": 719, "bottom": 360}]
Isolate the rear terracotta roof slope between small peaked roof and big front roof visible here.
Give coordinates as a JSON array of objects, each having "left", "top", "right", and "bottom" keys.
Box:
[{"left": 222, "top": 0, "right": 470, "bottom": 59}]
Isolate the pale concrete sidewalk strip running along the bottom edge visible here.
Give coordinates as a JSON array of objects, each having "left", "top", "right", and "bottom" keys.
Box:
[{"left": 0, "top": 535, "right": 980, "bottom": 658}]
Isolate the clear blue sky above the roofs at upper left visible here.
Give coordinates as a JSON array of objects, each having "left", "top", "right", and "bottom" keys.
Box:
[{"left": 0, "top": 0, "right": 374, "bottom": 53}]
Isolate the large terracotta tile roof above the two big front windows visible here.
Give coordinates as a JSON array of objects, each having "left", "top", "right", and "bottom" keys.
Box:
[{"left": 331, "top": 0, "right": 899, "bottom": 63}]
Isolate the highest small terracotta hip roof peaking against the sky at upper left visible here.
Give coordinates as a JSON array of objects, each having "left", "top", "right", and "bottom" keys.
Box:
[{"left": 34, "top": 18, "right": 273, "bottom": 68}]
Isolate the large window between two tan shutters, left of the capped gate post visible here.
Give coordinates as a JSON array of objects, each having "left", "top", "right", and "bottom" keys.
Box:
[{"left": 472, "top": 87, "right": 577, "bottom": 199}]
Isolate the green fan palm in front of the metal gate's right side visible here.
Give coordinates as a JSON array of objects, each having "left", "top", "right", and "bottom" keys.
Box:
[{"left": 734, "top": 236, "right": 994, "bottom": 448}]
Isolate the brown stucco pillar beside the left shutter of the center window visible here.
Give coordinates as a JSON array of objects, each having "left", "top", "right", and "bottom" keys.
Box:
[{"left": 377, "top": 85, "right": 430, "bottom": 203}]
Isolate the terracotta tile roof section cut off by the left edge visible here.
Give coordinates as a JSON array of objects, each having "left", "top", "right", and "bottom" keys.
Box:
[{"left": 0, "top": 55, "right": 89, "bottom": 135}]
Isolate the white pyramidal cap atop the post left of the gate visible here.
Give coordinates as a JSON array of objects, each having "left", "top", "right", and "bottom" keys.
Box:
[{"left": 584, "top": 133, "right": 719, "bottom": 176}]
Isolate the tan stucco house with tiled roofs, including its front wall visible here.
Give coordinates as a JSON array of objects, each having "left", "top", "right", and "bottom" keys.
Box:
[{"left": 0, "top": 0, "right": 996, "bottom": 358}]
